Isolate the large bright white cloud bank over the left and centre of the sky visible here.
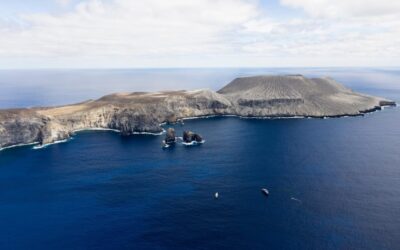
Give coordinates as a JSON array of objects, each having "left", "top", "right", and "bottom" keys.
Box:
[{"left": 0, "top": 0, "right": 257, "bottom": 56}]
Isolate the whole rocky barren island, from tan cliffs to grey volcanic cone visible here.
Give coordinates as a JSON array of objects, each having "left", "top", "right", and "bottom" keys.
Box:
[{"left": 0, "top": 75, "right": 394, "bottom": 148}]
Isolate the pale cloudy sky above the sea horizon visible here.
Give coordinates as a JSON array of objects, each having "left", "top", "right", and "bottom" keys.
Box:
[{"left": 0, "top": 0, "right": 400, "bottom": 69}]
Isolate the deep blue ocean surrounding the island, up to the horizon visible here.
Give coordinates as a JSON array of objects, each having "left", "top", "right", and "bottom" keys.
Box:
[{"left": 0, "top": 69, "right": 400, "bottom": 249}]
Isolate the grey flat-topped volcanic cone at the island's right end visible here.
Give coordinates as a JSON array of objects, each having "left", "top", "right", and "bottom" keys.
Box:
[{"left": 218, "top": 75, "right": 389, "bottom": 117}]
